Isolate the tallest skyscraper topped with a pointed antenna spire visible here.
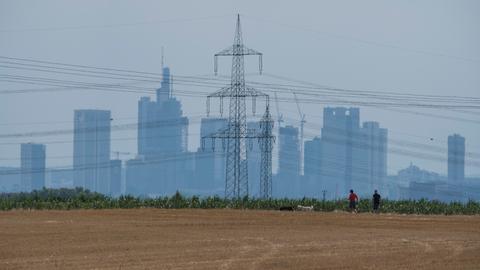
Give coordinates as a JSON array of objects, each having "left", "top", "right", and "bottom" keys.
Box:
[{"left": 126, "top": 63, "right": 190, "bottom": 195}]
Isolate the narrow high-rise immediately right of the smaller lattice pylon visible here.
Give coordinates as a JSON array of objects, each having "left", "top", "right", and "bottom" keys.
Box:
[{"left": 273, "top": 126, "right": 300, "bottom": 197}]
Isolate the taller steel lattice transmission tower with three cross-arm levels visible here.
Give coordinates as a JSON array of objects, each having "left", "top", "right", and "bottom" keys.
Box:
[{"left": 202, "top": 15, "right": 268, "bottom": 198}]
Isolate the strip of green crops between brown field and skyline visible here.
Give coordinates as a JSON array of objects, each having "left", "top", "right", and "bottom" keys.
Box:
[{"left": 0, "top": 188, "right": 480, "bottom": 215}]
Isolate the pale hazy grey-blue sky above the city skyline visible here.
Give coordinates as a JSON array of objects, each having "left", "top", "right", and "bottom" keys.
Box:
[{"left": 0, "top": 0, "right": 480, "bottom": 175}]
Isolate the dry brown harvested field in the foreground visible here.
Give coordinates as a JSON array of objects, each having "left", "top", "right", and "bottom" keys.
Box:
[{"left": 0, "top": 209, "right": 480, "bottom": 270}]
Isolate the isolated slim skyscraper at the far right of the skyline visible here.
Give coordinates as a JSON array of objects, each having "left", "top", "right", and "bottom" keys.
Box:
[{"left": 448, "top": 134, "right": 465, "bottom": 182}]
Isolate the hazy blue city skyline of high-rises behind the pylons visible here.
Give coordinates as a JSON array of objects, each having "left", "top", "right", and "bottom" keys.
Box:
[{"left": 0, "top": 54, "right": 475, "bottom": 200}]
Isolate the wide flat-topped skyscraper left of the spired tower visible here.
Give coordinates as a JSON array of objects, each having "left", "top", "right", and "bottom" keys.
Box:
[{"left": 73, "top": 110, "right": 110, "bottom": 194}]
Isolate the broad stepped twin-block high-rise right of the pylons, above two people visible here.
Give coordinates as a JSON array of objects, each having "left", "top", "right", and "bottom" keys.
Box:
[{"left": 320, "top": 107, "right": 387, "bottom": 198}]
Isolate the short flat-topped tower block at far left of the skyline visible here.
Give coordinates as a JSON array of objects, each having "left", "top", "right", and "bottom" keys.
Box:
[{"left": 20, "top": 143, "right": 45, "bottom": 192}]
